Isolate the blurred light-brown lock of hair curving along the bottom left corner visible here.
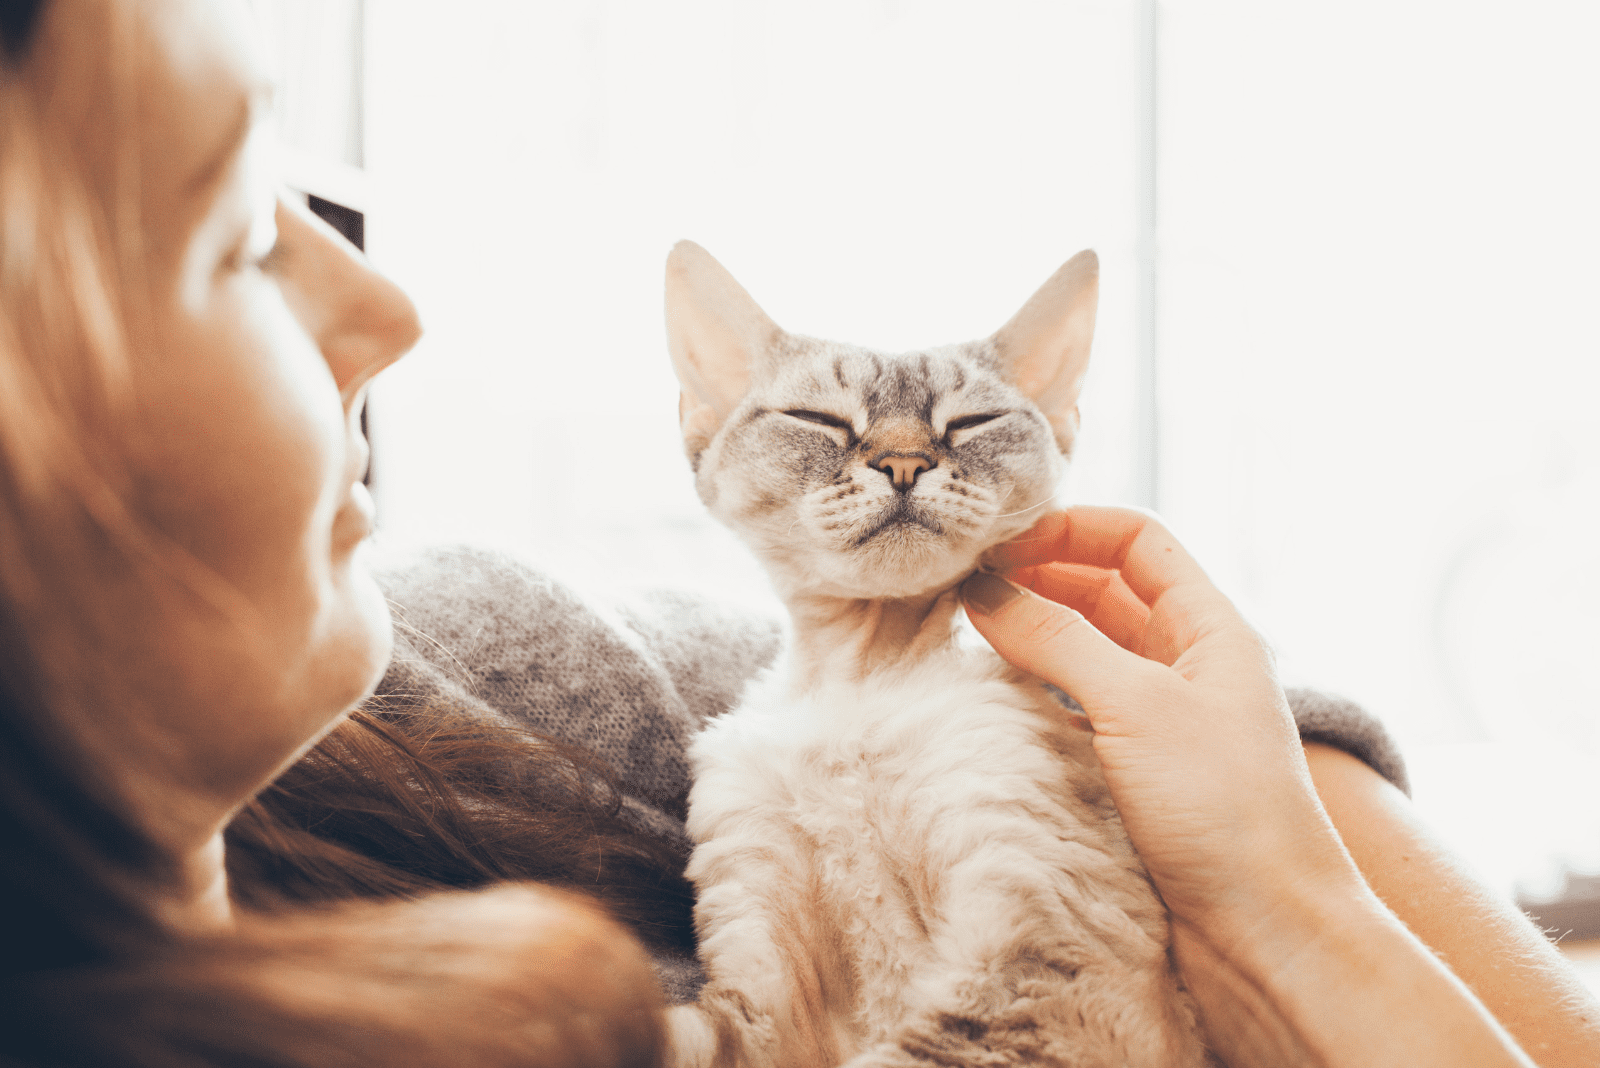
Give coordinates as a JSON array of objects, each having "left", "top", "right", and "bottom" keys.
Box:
[{"left": 0, "top": 886, "right": 662, "bottom": 1068}]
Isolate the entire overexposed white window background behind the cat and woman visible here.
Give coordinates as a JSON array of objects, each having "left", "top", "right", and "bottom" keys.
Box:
[{"left": 258, "top": 0, "right": 1600, "bottom": 952}]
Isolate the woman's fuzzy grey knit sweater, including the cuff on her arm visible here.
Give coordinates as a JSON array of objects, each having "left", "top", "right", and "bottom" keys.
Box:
[{"left": 378, "top": 547, "right": 1410, "bottom": 1001}]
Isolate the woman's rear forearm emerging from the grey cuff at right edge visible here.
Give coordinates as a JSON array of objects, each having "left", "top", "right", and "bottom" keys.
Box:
[{"left": 1306, "top": 745, "right": 1600, "bottom": 1068}]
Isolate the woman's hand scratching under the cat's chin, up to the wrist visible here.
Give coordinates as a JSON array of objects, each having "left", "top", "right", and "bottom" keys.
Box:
[{"left": 962, "top": 508, "right": 1365, "bottom": 953}]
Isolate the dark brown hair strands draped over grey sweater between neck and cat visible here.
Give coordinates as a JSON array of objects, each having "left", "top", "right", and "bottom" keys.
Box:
[{"left": 227, "top": 699, "right": 694, "bottom": 950}]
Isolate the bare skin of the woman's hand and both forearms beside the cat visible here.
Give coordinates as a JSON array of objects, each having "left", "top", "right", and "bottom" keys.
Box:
[{"left": 963, "top": 508, "right": 1600, "bottom": 1068}]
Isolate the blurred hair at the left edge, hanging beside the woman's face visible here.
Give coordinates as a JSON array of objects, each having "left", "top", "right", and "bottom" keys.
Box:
[{"left": 0, "top": 6, "right": 172, "bottom": 969}]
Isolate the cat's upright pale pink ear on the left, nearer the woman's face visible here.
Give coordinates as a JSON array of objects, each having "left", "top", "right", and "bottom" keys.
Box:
[{"left": 667, "top": 241, "right": 782, "bottom": 457}]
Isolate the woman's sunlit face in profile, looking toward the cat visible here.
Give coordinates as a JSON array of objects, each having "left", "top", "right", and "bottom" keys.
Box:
[{"left": 68, "top": 0, "right": 419, "bottom": 841}]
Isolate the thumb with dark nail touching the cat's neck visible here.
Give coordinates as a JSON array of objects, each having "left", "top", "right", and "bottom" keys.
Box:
[{"left": 962, "top": 571, "right": 1162, "bottom": 719}]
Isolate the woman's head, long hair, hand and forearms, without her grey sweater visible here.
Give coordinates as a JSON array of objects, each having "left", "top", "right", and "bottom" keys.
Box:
[{"left": 0, "top": 0, "right": 1597, "bottom": 1065}]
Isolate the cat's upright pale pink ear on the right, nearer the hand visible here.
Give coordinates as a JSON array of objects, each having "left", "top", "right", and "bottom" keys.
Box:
[{"left": 990, "top": 249, "right": 1099, "bottom": 452}]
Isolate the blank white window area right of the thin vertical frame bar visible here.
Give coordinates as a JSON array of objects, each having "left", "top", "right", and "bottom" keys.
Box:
[{"left": 1158, "top": 0, "right": 1600, "bottom": 886}]
